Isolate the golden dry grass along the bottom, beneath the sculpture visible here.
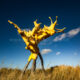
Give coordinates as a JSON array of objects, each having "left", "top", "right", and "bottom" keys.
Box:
[{"left": 0, "top": 65, "right": 80, "bottom": 80}]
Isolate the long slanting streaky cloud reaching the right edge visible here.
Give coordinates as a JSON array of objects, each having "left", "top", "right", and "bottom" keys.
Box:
[{"left": 53, "top": 27, "right": 80, "bottom": 42}]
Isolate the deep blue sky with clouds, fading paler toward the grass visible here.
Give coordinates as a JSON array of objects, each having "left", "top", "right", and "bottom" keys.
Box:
[{"left": 0, "top": 0, "right": 80, "bottom": 69}]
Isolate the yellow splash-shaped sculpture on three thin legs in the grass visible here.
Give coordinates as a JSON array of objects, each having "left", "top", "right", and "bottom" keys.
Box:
[{"left": 8, "top": 16, "right": 65, "bottom": 74}]
